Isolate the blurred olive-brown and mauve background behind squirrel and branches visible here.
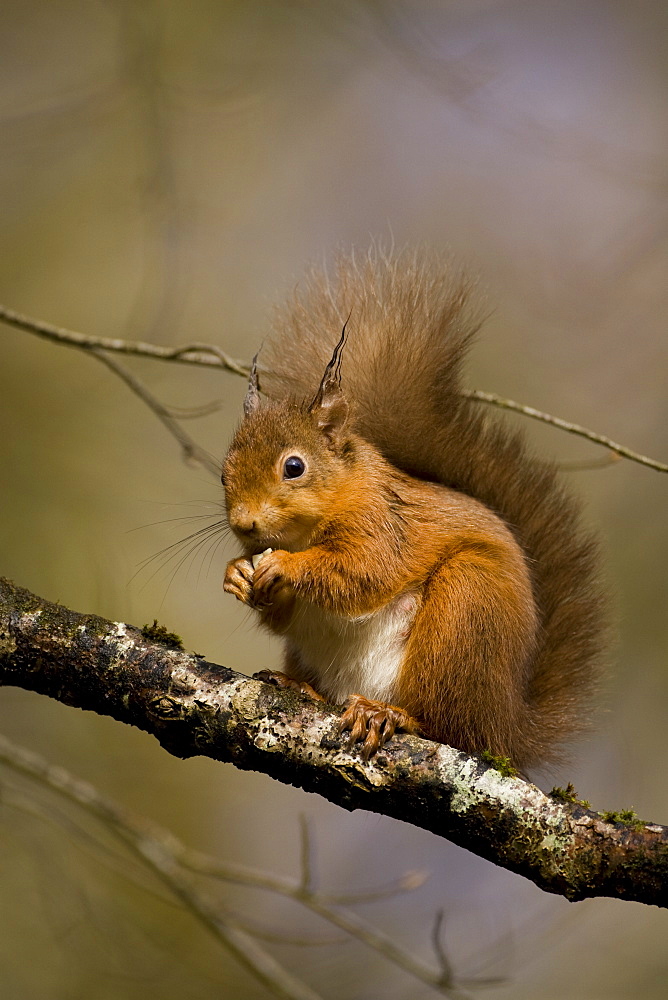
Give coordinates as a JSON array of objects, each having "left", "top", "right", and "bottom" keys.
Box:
[{"left": 0, "top": 0, "right": 668, "bottom": 1000}]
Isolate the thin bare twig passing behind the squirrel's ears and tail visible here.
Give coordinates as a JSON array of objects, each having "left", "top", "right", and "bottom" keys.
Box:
[{"left": 0, "top": 298, "right": 668, "bottom": 472}]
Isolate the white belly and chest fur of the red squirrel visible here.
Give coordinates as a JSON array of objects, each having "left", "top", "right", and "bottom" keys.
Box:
[{"left": 286, "top": 594, "right": 418, "bottom": 702}]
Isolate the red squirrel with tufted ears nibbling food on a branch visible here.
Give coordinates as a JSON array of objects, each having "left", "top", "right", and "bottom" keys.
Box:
[{"left": 222, "top": 249, "right": 603, "bottom": 769}]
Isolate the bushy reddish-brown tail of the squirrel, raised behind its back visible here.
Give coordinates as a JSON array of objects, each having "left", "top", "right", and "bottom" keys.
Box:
[{"left": 261, "top": 249, "right": 604, "bottom": 761}]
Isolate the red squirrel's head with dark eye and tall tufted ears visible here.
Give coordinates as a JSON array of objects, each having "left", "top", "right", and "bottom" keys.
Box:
[{"left": 221, "top": 327, "right": 354, "bottom": 553}]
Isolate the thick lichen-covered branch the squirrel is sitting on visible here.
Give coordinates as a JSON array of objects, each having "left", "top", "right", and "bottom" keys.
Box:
[{"left": 0, "top": 578, "right": 668, "bottom": 906}]
